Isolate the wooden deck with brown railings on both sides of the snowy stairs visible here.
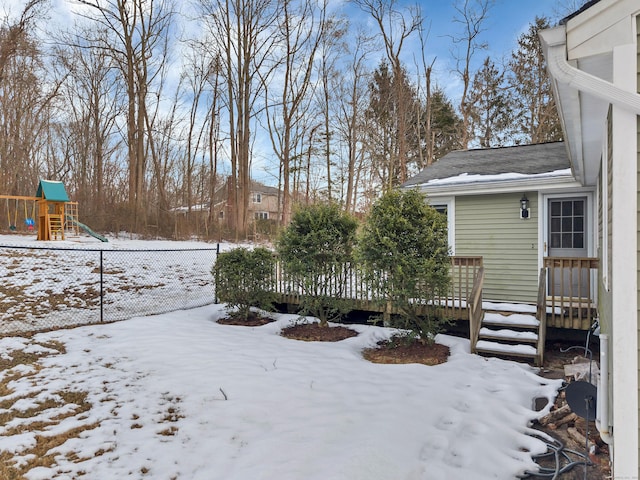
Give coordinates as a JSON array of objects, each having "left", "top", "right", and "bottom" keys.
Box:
[{"left": 271, "top": 256, "right": 598, "bottom": 335}]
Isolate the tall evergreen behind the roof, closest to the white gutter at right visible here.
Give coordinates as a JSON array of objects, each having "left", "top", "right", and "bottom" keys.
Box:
[{"left": 508, "top": 17, "right": 562, "bottom": 143}]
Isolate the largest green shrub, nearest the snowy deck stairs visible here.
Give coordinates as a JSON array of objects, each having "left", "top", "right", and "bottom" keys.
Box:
[{"left": 358, "top": 190, "right": 450, "bottom": 342}]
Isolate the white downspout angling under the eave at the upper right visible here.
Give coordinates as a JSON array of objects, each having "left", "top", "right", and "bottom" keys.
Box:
[{"left": 540, "top": 26, "right": 640, "bottom": 115}]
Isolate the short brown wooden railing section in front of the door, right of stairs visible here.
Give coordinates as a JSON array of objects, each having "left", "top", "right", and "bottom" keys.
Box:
[{"left": 540, "top": 257, "right": 599, "bottom": 330}]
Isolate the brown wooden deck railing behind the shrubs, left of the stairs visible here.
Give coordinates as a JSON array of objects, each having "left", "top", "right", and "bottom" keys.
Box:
[{"left": 272, "top": 256, "right": 482, "bottom": 319}]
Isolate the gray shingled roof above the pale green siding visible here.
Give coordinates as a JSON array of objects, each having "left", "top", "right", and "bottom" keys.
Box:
[{"left": 402, "top": 142, "right": 570, "bottom": 187}]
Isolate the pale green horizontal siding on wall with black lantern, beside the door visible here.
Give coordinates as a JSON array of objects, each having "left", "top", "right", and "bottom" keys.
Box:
[{"left": 455, "top": 192, "right": 539, "bottom": 303}]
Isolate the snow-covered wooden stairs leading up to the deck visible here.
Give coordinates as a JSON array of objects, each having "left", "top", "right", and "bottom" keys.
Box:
[{"left": 471, "top": 302, "right": 545, "bottom": 365}]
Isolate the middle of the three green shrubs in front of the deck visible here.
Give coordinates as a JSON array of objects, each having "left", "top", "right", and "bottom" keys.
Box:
[{"left": 276, "top": 204, "right": 358, "bottom": 326}]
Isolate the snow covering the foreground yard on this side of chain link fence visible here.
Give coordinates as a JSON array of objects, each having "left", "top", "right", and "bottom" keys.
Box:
[{"left": 0, "top": 305, "right": 559, "bottom": 480}]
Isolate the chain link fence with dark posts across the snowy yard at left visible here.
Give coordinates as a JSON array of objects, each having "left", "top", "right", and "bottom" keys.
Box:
[{"left": 0, "top": 245, "right": 219, "bottom": 336}]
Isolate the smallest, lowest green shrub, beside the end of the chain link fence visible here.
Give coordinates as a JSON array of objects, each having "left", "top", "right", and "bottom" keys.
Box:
[{"left": 212, "top": 247, "right": 275, "bottom": 320}]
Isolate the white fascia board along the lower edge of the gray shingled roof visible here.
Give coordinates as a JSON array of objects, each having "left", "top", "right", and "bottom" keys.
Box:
[{"left": 414, "top": 175, "right": 582, "bottom": 197}]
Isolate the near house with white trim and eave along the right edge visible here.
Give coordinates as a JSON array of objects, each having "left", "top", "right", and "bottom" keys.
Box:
[{"left": 540, "top": 0, "right": 640, "bottom": 479}]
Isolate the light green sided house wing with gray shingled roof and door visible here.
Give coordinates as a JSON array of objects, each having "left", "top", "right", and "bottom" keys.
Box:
[{"left": 403, "top": 142, "right": 596, "bottom": 312}]
